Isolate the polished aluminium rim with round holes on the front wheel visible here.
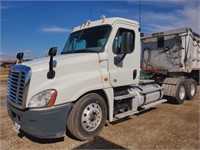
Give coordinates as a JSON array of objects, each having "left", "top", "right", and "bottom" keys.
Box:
[{"left": 81, "top": 103, "right": 102, "bottom": 132}]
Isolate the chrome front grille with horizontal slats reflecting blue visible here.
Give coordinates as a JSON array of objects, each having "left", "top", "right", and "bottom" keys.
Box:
[{"left": 7, "top": 65, "right": 31, "bottom": 109}]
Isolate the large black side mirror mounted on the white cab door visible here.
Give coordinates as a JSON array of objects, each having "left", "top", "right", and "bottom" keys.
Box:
[{"left": 121, "top": 32, "right": 133, "bottom": 54}]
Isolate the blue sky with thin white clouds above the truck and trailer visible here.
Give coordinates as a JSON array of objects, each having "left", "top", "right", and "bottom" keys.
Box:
[{"left": 0, "top": 0, "right": 200, "bottom": 60}]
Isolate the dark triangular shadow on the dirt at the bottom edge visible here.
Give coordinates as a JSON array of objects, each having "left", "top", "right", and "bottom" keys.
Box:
[{"left": 74, "top": 136, "right": 126, "bottom": 150}]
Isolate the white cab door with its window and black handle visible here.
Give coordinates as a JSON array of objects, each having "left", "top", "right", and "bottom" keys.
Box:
[{"left": 108, "top": 22, "right": 140, "bottom": 87}]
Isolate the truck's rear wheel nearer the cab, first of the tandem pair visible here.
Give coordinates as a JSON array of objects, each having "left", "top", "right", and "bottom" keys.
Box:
[{"left": 175, "top": 79, "right": 186, "bottom": 104}]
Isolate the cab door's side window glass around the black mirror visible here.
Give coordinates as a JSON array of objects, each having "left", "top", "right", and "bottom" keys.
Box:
[{"left": 113, "top": 28, "right": 135, "bottom": 54}]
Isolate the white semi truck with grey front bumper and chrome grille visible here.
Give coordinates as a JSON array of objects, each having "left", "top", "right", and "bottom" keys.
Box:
[{"left": 7, "top": 18, "right": 196, "bottom": 140}]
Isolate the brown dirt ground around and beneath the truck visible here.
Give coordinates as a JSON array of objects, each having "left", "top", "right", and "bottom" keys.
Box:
[{"left": 0, "top": 67, "right": 200, "bottom": 150}]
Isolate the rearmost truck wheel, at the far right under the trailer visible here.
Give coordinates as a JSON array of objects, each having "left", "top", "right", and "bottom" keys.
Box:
[{"left": 185, "top": 79, "right": 197, "bottom": 100}]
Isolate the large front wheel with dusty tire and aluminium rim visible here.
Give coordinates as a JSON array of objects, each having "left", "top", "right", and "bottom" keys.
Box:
[{"left": 67, "top": 93, "right": 107, "bottom": 141}]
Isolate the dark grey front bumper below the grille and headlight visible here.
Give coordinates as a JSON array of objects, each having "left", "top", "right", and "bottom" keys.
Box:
[{"left": 7, "top": 103, "right": 72, "bottom": 138}]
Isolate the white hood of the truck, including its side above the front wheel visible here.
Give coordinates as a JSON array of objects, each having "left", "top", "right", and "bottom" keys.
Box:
[{"left": 23, "top": 53, "right": 103, "bottom": 107}]
